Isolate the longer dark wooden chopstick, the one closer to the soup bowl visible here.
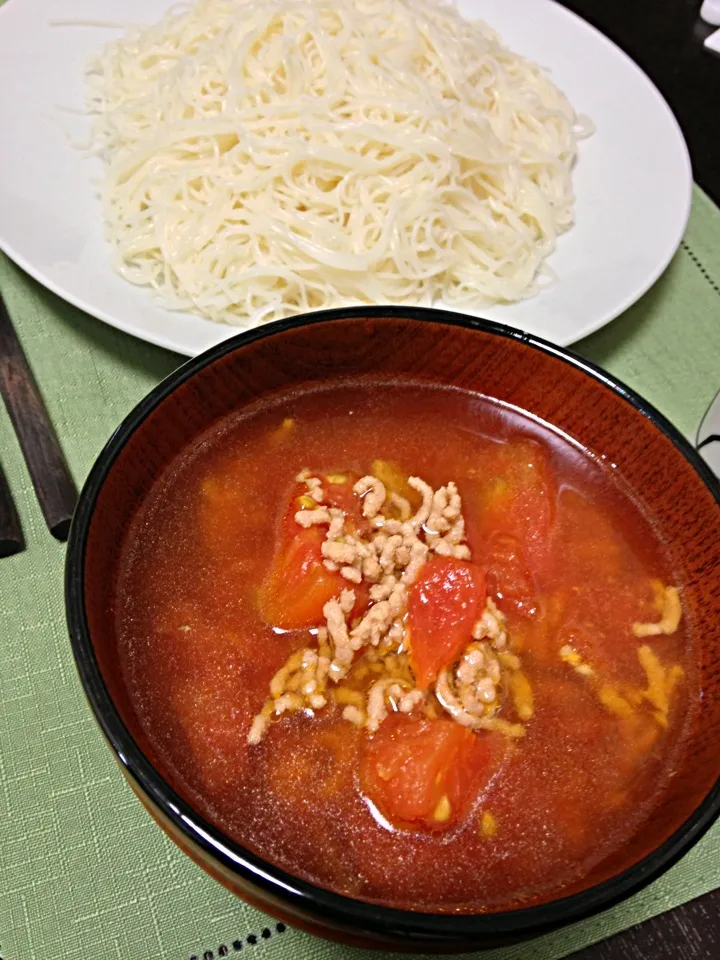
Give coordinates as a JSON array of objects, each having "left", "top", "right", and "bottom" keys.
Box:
[{"left": 0, "top": 297, "right": 78, "bottom": 540}]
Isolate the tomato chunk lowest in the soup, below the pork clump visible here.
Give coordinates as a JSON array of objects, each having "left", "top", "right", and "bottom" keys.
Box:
[{"left": 360, "top": 714, "right": 498, "bottom": 830}]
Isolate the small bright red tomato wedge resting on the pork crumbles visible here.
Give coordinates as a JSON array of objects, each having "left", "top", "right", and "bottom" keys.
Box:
[{"left": 408, "top": 557, "right": 486, "bottom": 690}]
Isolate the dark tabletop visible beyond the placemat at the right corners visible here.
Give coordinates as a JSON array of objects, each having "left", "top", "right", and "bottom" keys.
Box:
[{"left": 556, "top": 0, "right": 720, "bottom": 960}]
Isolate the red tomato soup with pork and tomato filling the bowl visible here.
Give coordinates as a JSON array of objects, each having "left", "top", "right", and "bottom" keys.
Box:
[{"left": 116, "top": 383, "right": 697, "bottom": 912}]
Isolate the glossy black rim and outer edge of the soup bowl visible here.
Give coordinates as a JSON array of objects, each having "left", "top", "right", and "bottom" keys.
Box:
[{"left": 65, "top": 306, "right": 720, "bottom": 946}]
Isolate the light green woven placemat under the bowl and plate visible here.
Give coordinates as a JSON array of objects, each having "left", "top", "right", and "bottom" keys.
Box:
[{"left": 0, "top": 182, "right": 720, "bottom": 960}]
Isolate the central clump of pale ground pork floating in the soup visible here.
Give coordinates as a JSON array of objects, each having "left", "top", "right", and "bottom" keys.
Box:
[{"left": 248, "top": 469, "right": 527, "bottom": 743}]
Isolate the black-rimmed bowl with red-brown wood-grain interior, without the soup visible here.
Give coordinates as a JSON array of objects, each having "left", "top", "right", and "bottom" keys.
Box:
[{"left": 67, "top": 308, "right": 720, "bottom": 951}]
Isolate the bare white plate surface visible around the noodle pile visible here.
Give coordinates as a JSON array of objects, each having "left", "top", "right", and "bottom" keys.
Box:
[{"left": 0, "top": 0, "right": 692, "bottom": 355}]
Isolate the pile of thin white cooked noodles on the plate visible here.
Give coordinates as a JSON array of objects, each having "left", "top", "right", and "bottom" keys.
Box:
[{"left": 89, "top": 0, "right": 589, "bottom": 325}]
